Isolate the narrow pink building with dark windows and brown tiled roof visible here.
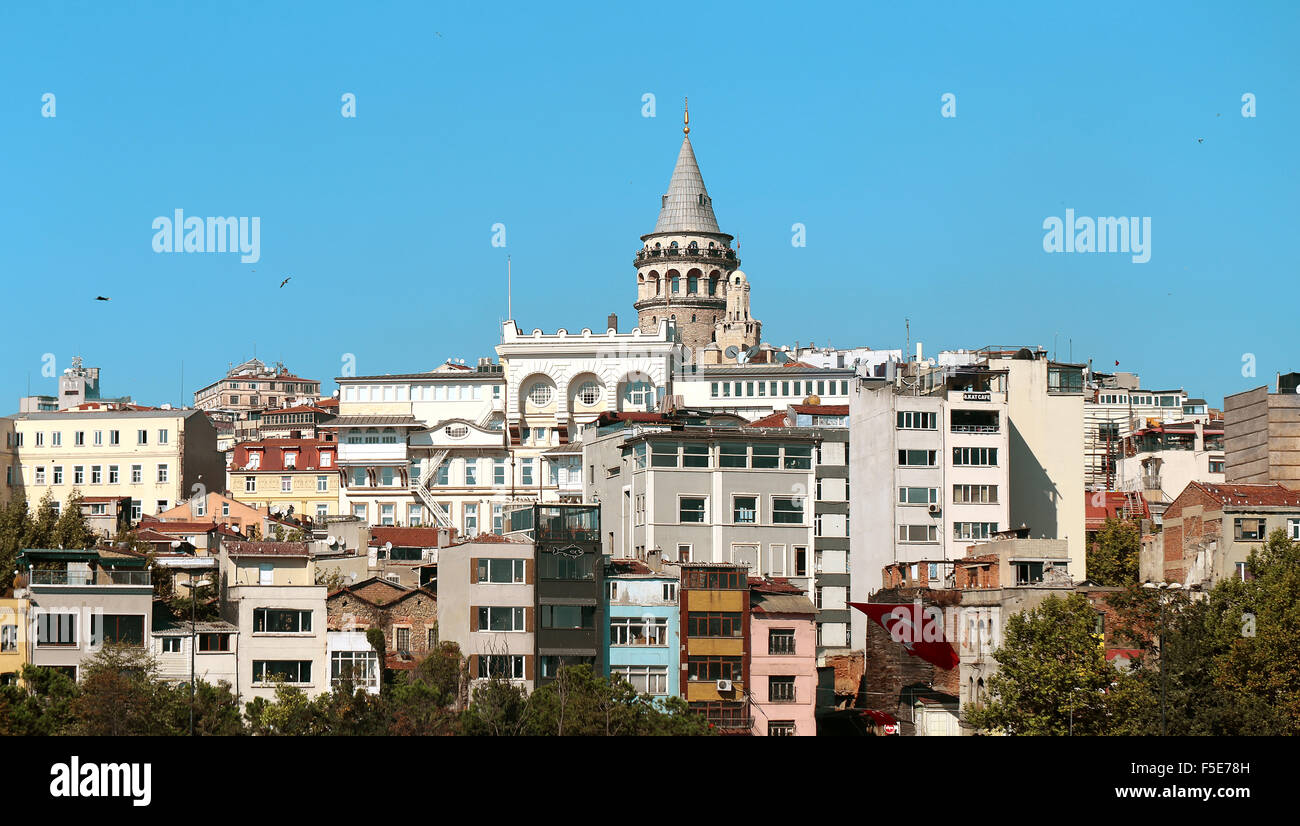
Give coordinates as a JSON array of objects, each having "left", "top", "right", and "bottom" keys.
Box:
[{"left": 749, "top": 578, "right": 816, "bottom": 738}]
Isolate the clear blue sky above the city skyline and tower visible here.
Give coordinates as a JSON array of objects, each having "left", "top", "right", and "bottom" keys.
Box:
[{"left": 0, "top": 3, "right": 1300, "bottom": 411}]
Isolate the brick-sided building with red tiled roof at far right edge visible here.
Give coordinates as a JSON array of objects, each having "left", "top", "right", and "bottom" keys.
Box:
[{"left": 1141, "top": 481, "right": 1300, "bottom": 588}]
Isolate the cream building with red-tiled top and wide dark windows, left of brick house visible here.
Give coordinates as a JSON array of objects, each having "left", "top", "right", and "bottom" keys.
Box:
[{"left": 218, "top": 541, "right": 330, "bottom": 702}]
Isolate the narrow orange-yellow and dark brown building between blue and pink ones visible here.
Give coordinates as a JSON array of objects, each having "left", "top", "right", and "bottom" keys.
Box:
[{"left": 679, "top": 562, "right": 754, "bottom": 735}]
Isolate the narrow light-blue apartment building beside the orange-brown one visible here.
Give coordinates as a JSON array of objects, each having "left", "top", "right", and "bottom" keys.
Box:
[{"left": 605, "top": 559, "right": 681, "bottom": 699}]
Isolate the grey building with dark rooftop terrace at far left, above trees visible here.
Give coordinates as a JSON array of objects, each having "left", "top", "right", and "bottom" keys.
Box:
[{"left": 14, "top": 549, "right": 153, "bottom": 680}]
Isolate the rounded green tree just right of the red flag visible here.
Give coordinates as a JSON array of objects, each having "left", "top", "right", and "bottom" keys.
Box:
[{"left": 963, "top": 593, "right": 1135, "bottom": 735}]
